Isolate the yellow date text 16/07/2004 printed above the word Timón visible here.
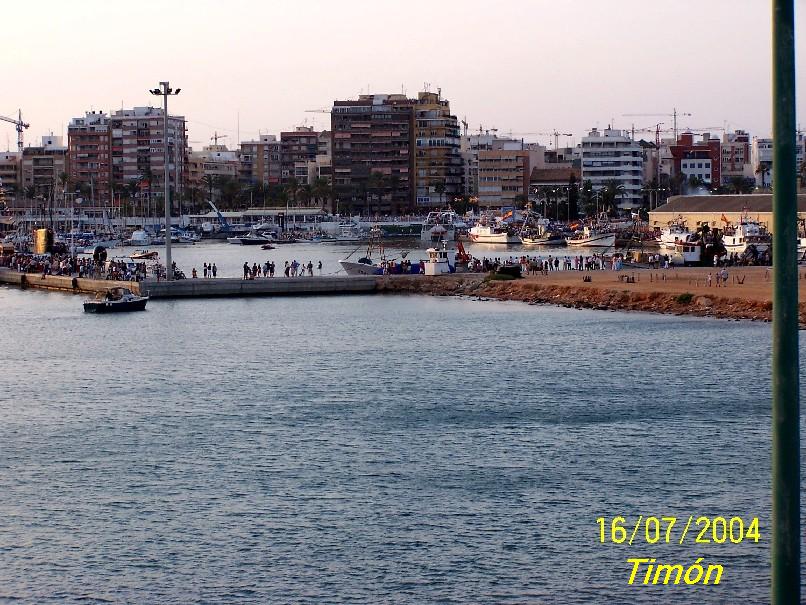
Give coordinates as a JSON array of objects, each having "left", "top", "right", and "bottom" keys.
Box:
[{"left": 596, "top": 515, "right": 760, "bottom": 545}]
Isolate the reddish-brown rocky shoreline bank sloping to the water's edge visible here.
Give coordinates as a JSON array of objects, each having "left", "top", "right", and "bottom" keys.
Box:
[{"left": 378, "top": 274, "right": 806, "bottom": 328}]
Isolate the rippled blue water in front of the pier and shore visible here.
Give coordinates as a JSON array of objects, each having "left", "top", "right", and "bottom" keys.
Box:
[{"left": 0, "top": 289, "right": 804, "bottom": 603}]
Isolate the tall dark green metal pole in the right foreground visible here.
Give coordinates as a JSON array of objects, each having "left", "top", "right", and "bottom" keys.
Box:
[{"left": 771, "top": 0, "right": 800, "bottom": 605}]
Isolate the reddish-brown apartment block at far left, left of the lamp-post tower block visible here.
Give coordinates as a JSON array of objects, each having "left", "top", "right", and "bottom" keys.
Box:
[{"left": 67, "top": 111, "right": 112, "bottom": 204}]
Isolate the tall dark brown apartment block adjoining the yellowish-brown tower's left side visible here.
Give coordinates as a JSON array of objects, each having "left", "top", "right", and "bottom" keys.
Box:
[{"left": 331, "top": 94, "right": 416, "bottom": 213}]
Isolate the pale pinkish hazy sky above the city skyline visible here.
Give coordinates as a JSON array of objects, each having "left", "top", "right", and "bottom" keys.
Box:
[{"left": 0, "top": 0, "right": 806, "bottom": 150}]
